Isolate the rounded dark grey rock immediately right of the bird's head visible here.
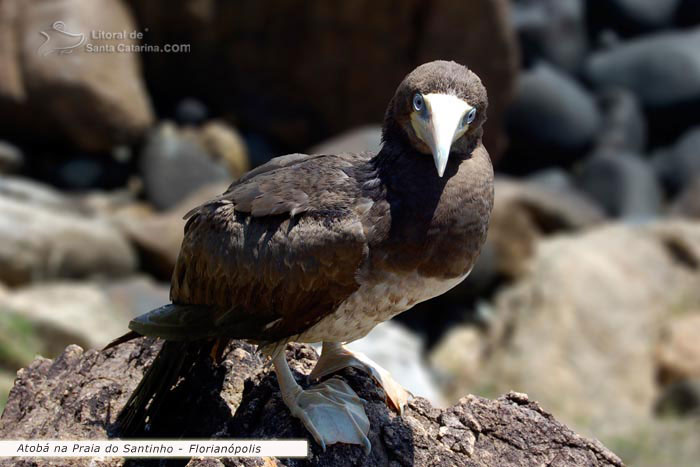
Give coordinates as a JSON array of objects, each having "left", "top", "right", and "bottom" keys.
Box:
[{"left": 501, "top": 63, "right": 601, "bottom": 172}]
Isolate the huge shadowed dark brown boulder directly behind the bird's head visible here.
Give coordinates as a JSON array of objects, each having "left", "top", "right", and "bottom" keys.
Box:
[{"left": 129, "top": 0, "right": 518, "bottom": 161}]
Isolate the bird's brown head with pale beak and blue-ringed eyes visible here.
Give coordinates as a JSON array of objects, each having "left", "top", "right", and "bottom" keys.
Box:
[{"left": 383, "top": 60, "right": 488, "bottom": 177}]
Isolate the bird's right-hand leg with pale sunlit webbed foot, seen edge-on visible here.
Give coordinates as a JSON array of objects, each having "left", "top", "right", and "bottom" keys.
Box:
[{"left": 310, "top": 342, "right": 412, "bottom": 414}]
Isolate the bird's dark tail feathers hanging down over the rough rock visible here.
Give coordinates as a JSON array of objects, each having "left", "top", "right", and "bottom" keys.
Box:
[{"left": 115, "top": 340, "right": 190, "bottom": 438}]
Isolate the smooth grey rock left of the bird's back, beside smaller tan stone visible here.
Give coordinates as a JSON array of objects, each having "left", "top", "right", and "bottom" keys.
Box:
[{"left": 141, "top": 123, "right": 231, "bottom": 210}]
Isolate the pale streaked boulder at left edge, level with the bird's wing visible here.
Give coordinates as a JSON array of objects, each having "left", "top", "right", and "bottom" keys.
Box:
[{"left": 0, "top": 179, "right": 136, "bottom": 285}]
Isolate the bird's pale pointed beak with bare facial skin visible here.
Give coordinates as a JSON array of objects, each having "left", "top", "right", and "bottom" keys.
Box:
[{"left": 411, "top": 94, "right": 472, "bottom": 177}]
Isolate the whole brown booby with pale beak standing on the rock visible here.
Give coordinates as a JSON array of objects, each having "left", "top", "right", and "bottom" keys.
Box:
[{"left": 113, "top": 61, "right": 493, "bottom": 450}]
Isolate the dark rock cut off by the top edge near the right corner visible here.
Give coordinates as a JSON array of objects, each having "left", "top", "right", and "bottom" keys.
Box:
[{"left": 587, "top": 0, "right": 681, "bottom": 36}]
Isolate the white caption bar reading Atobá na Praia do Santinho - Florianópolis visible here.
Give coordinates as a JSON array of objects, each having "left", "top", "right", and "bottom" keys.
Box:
[{"left": 0, "top": 440, "right": 309, "bottom": 457}]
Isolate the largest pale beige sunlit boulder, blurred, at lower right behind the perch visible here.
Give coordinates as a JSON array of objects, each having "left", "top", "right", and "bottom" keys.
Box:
[{"left": 445, "top": 222, "right": 700, "bottom": 439}]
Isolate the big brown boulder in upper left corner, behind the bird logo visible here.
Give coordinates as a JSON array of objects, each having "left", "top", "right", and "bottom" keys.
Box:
[{"left": 0, "top": 0, "right": 153, "bottom": 151}]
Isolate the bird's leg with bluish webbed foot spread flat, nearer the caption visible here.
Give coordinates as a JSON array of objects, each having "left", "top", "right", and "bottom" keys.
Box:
[{"left": 272, "top": 350, "right": 372, "bottom": 453}]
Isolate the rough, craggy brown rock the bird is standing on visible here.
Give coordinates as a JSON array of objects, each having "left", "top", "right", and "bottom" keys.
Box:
[{"left": 0, "top": 339, "right": 622, "bottom": 466}]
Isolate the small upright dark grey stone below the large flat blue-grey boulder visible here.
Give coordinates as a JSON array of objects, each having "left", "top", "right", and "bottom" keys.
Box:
[{"left": 596, "top": 89, "right": 647, "bottom": 153}]
